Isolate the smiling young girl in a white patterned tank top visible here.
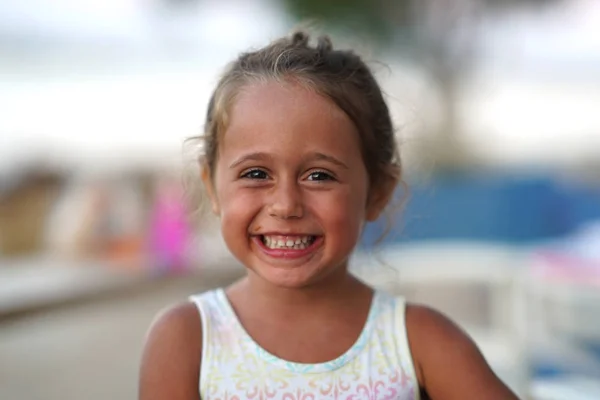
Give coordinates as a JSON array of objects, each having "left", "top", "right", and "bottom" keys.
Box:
[{"left": 140, "top": 29, "right": 516, "bottom": 400}]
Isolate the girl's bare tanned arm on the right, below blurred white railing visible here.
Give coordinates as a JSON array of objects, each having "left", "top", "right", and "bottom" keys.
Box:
[{"left": 406, "top": 305, "right": 517, "bottom": 400}]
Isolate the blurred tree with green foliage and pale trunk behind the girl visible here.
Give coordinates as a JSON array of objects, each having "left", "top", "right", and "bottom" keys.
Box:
[{"left": 282, "top": 0, "right": 561, "bottom": 172}]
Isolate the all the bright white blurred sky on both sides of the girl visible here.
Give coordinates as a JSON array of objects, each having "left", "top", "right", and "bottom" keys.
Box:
[{"left": 0, "top": 0, "right": 600, "bottom": 172}]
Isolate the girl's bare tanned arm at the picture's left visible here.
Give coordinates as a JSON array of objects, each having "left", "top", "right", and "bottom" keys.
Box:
[{"left": 138, "top": 303, "right": 202, "bottom": 400}]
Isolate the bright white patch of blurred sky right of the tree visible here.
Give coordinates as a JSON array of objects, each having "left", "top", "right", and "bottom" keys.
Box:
[{"left": 463, "top": 0, "right": 600, "bottom": 164}]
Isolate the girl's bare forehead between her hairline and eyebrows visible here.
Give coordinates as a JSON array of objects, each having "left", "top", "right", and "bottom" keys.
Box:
[{"left": 220, "top": 81, "right": 361, "bottom": 162}]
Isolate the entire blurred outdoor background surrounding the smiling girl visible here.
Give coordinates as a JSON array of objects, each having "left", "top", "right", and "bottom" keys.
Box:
[{"left": 0, "top": 0, "right": 600, "bottom": 400}]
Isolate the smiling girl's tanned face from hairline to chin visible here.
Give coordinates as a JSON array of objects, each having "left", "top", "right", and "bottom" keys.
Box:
[{"left": 204, "top": 82, "right": 385, "bottom": 288}]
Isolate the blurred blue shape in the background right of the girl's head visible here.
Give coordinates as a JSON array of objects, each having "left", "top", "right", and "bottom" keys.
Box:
[{"left": 363, "top": 175, "right": 600, "bottom": 246}]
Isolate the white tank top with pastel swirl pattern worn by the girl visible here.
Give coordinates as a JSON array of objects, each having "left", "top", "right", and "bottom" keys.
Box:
[{"left": 190, "top": 289, "right": 419, "bottom": 400}]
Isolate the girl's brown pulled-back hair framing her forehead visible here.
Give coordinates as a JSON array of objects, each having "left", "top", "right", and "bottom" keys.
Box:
[{"left": 196, "top": 31, "right": 401, "bottom": 194}]
